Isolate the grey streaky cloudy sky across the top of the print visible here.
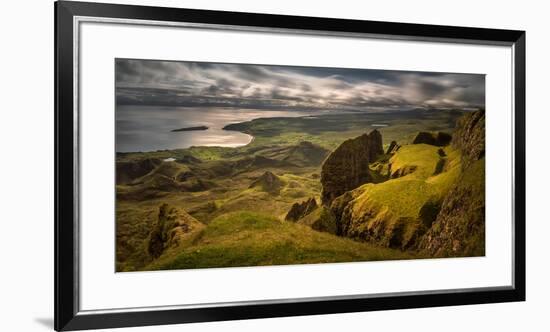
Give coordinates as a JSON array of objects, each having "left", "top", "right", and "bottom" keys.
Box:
[{"left": 115, "top": 59, "right": 485, "bottom": 110}]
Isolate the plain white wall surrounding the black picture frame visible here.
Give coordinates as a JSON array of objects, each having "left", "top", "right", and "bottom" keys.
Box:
[{"left": 0, "top": 0, "right": 550, "bottom": 332}]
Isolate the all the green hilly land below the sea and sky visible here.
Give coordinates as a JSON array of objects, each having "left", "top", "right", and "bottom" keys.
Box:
[{"left": 116, "top": 109, "right": 485, "bottom": 272}]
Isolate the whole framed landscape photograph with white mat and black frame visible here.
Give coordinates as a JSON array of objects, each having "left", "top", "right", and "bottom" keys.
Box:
[{"left": 55, "top": 1, "right": 525, "bottom": 330}]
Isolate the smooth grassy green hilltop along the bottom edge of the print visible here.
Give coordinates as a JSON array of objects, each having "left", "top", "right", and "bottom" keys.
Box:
[{"left": 145, "top": 211, "right": 413, "bottom": 270}]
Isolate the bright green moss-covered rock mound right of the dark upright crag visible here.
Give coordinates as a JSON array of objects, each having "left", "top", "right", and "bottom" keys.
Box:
[{"left": 330, "top": 135, "right": 461, "bottom": 249}]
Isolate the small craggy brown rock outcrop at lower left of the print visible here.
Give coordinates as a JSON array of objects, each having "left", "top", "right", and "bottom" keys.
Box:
[{"left": 147, "top": 204, "right": 204, "bottom": 258}]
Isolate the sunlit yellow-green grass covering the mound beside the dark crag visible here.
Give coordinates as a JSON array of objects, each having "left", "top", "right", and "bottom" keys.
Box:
[{"left": 338, "top": 144, "right": 461, "bottom": 247}]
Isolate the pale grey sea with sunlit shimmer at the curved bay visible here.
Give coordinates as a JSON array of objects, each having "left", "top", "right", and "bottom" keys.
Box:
[{"left": 115, "top": 105, "right": 319, "bottom": 152}]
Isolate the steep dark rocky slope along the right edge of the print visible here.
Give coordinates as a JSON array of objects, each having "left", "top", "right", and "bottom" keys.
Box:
[{"left": 418, "top": 110, "right": 485, "bottom": 257}]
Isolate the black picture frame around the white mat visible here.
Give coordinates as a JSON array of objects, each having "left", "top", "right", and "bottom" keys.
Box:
[{"left": 55, "top": 1, "right": 525, "bottom": 331}]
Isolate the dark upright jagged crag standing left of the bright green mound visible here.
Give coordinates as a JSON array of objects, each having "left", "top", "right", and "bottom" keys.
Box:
[{"left": 321, "top": 130, "right": 384, "bottom": 205}]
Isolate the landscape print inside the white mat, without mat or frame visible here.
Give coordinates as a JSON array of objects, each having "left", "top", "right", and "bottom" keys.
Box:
[{"left": 115, "top": 59, "right": 485, "bottom": 272}]
